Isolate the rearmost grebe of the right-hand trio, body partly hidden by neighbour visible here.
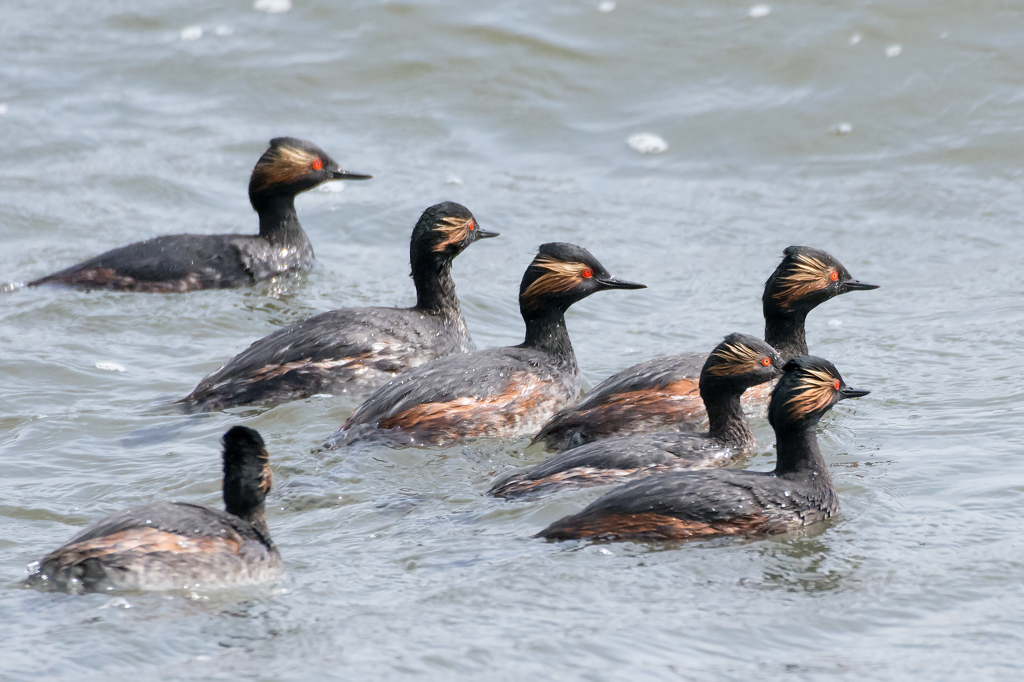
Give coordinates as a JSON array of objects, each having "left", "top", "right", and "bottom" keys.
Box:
[{"left": 534, "top": 246, "right": 879, "bottom": 450}]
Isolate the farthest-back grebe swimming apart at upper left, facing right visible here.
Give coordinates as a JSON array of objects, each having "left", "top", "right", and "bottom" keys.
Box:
[{"left": 29, "top": 137, "right": 372, "bottom": 293}]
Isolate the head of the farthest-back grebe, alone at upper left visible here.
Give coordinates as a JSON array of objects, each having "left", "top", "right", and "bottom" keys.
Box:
[{"left": 249, "top": 137, "right": 373, "bottom": 210}]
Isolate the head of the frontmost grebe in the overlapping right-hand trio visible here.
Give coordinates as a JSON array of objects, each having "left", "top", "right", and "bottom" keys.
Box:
[{"left": 768, "top": 355, "right": 870, "bottom": 430}]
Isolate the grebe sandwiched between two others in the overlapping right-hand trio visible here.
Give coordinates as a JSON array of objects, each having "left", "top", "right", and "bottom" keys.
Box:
[{"left": 489, "top": 334, "right": 783, "bottom": 499}]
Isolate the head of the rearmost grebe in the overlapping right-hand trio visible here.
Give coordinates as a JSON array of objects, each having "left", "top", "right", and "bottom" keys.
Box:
[{"left": 761, "top": 246, "right": 879, "bottom": 317}]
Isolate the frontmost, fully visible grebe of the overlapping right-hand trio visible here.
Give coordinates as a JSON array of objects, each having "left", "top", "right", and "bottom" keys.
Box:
[{"left": 537, "top": 355, "right": 868, "bottom": 540}]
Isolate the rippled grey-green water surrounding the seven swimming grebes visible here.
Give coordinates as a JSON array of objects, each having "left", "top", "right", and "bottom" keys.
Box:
[{"left": 0, "top": 0, "right": 1024, "bottom": 680}]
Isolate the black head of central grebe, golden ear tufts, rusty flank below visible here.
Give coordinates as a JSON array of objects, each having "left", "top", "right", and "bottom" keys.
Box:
[{"left": 519, "top": 242, "right": 647, "bottom": 317}]
